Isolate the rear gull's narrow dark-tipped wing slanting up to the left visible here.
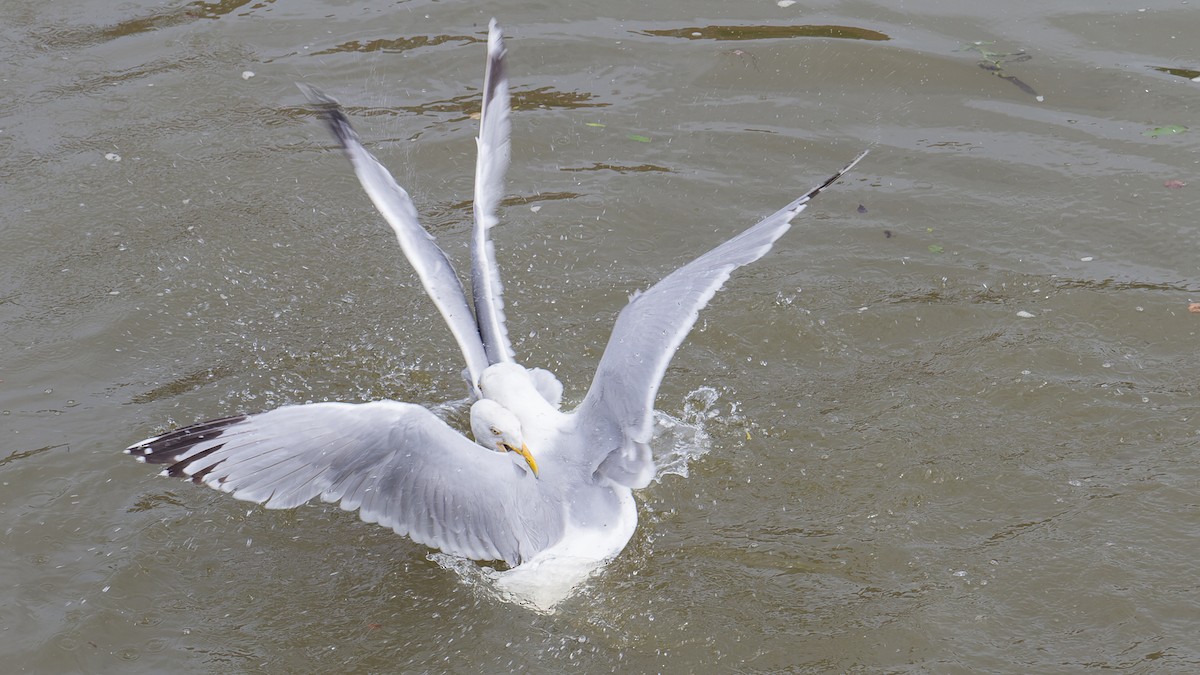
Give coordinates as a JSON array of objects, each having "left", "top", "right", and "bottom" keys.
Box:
[{"left": 296, "top": 84, "right": 488, "bottom": 398}]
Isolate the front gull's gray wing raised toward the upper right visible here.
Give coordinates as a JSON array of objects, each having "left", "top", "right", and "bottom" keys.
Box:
[{"left": 576, "top": 151, "right": 866, "bottom": 488}]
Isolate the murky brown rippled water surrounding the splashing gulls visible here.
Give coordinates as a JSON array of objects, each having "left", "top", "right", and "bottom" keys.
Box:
[{"left": 0, "top": 0, "right": 1200, "bottom": 673}]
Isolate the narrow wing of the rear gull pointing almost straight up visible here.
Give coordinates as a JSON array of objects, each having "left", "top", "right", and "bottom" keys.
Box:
[{"left": 470, "top": 19, "right": 512, "bottom": 363}]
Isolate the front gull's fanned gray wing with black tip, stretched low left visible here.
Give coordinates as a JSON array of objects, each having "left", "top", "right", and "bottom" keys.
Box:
[{"left": 126, "top": 401, "right": 563, "bottom": 565}]
